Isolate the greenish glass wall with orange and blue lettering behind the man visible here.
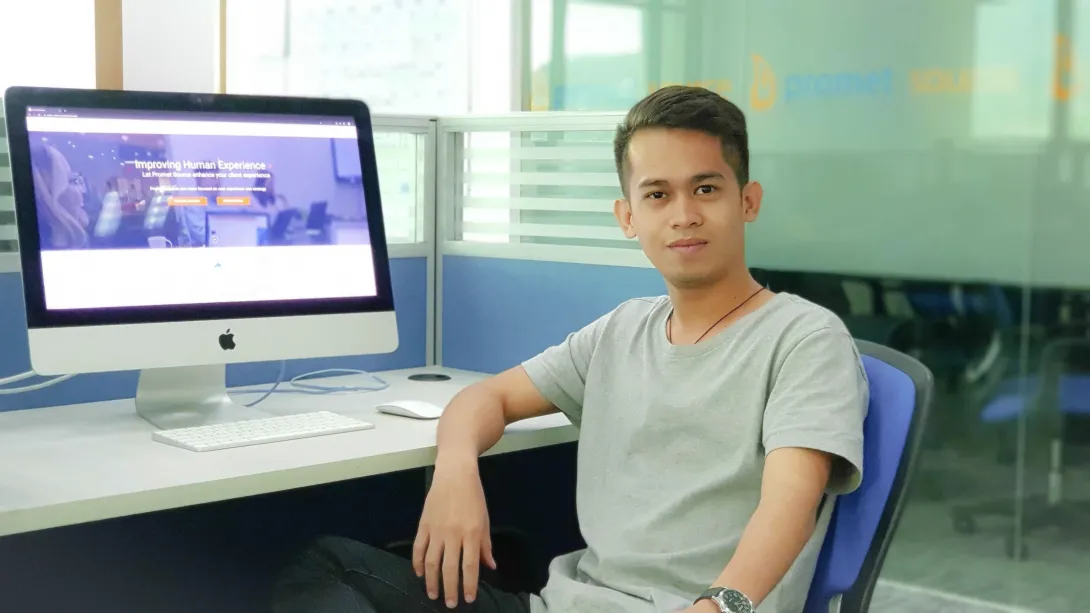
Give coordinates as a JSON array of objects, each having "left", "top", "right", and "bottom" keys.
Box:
[{"left": 520, "top": 0, "right": 1090, "bottom": 613}]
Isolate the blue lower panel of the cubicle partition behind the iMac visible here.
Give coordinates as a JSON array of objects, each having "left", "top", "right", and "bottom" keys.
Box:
[{"left": 0, "top": 257, "right": 427, "bottom": 411}]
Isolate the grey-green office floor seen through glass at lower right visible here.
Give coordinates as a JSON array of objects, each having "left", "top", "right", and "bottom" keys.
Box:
[{"left": 872, "top": 454, "right": 1090, "bottom": 613}]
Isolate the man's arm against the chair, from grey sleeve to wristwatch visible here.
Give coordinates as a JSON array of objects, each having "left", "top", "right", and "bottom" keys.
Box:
[{"left": 691, "top": 327, "right": 869, "bottom": 613}]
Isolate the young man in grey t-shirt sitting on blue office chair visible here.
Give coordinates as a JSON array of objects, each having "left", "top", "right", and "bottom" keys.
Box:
[{"left": 277, "top": 86, "right": 868, "bottom": 613}]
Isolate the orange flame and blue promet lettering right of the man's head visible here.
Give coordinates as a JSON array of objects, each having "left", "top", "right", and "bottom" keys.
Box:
[{"left": 750, "top": 53, "right": 893, "bottom": 111}]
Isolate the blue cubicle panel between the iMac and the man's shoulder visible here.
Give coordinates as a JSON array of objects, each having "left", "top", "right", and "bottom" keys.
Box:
[{"left": 441, "top": 255, "right": 666, "bottom": 373}]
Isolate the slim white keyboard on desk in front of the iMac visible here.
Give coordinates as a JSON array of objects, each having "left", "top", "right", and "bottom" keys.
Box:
[{"left": 152, "top": 411, "right": 375, "bottom": 452}]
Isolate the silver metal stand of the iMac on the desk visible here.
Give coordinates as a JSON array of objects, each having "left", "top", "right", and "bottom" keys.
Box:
[{"left": 136, "top": 364, "right": 273, "bottom": 430}]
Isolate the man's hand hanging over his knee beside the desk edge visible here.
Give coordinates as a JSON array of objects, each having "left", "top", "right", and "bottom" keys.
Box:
[{"left": 412, "top": 455, "right": 496, "bottom": 609}]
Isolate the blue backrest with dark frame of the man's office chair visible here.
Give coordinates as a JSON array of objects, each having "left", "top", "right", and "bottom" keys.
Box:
[{"left": 806, "top": 340, "right": 934, "bottom": 613}]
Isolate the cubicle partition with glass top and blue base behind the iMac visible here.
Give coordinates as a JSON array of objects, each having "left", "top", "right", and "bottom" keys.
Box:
[{"left": 0, "top": 116, "right": 436, "bottom": 411}]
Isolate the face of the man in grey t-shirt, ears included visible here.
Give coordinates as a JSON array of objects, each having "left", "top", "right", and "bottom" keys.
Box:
[{"left": 614, "top": 128, "right": 762, "bottom": 288}]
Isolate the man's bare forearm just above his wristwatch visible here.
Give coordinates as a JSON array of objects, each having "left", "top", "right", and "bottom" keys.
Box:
[{"left": 714, "top": 504, "right": 815, "bottom": 605}]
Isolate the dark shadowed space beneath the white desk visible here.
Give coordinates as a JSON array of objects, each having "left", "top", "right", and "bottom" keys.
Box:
[{"left": 0, "top": 444, "right": 585, "bottom": 613}]
